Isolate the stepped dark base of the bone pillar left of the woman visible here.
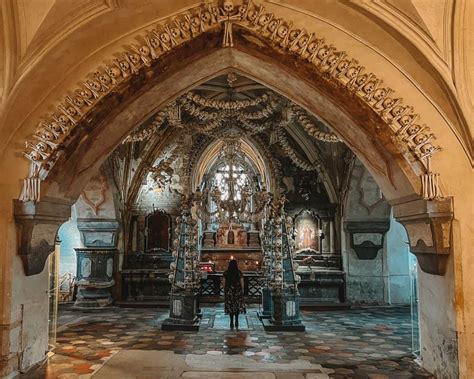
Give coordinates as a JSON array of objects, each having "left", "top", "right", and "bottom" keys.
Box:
[{"left": 161, "top": 292, "right": 201, "bottom": 331}]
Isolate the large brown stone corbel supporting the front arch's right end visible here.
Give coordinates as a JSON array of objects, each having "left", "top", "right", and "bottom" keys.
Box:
[{"left": 392, "top": 197, "right": 454, "bottom": 275}]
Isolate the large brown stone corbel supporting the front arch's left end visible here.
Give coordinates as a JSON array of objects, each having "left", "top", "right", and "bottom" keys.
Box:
[{"left": 14, "top": 198, "right": 72, "bottom": 276}]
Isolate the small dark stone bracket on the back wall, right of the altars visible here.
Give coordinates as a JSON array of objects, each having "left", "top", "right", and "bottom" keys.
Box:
[{"left": 345, "top": 220, "right": 390, "bottom": 259}]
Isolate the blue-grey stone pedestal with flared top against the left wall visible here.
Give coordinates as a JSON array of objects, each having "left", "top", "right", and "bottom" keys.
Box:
[{"left": 74, "top": 219, "right": 120, "bottom": 310}]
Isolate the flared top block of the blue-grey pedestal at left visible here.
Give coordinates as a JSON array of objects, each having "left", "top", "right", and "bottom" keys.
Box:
[{"left": 77, "top": 218, "right": 120, "bottom": 248}]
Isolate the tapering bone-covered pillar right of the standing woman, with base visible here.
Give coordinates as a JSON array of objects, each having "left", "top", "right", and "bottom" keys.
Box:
[{"left": 261, "top": 196, "right": 305, "bottom": 331}]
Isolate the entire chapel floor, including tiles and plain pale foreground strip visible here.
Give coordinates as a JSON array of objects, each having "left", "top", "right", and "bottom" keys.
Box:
[{"left": 22, "top": 305, "right": 432, "bottom": 379}]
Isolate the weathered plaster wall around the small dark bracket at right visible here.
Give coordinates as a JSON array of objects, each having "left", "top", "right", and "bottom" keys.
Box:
[{"left": 342, "top": 161, "right": 410, "bottom": 304}]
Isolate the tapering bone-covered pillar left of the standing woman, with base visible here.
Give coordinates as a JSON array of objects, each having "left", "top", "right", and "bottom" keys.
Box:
[{"left": 161, "top": 199, "right": 201, "bottom": 331}]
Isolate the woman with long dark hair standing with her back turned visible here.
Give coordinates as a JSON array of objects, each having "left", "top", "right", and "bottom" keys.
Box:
[{"left": 223, "top": 259, "right": 244, "bottom": 329}]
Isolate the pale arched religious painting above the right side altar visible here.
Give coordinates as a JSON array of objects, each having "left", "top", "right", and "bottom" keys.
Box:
[{"left": 295, "top": 210, "right": 321, "bottom": 252}]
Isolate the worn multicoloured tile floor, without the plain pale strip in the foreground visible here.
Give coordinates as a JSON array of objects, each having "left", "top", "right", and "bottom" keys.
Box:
[{"left": 22, "top": 305, "right": 431, "bottom": 379}]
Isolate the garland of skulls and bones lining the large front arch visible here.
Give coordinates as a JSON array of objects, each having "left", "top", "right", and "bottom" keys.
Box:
[{"left": 21, "top": 1, "right": 441, "bottom": 205}]
